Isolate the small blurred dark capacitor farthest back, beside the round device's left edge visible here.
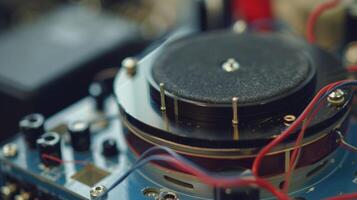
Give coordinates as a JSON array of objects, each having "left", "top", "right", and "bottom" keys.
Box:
[{"left": 88, "top": 81, "right": 108, "bottom": 111}]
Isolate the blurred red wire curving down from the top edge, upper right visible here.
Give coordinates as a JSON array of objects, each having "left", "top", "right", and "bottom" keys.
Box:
[{"left": 306, "top": 0, "right": 341, "bottom": 43}]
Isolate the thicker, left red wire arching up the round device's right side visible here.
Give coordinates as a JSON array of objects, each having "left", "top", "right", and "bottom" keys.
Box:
[{"left": 252, "top": 81, "right": 344, "bottom": 176}]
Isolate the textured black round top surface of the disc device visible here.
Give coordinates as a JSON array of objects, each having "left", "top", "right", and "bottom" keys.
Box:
[{"left": 153, "top": 32, "right": 313, "bottom": 105}]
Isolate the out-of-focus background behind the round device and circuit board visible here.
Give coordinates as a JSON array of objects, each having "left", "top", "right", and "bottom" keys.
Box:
[{"left": 0, "top": 0, "right": 357, "bottom": 139}]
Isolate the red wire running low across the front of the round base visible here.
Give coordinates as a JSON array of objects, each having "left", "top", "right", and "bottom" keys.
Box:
[{"left": 157, "top": 156, "right": 290, "bottom": 200}]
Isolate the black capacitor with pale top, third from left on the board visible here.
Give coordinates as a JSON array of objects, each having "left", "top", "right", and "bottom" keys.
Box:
[{"left": 67, "top": 121, "right": 91, "bottom": 151}]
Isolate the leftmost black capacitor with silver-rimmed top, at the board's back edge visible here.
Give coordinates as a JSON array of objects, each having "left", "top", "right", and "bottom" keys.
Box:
[{"left": 19, "top": 113, "right": 45, "bottom": 148}]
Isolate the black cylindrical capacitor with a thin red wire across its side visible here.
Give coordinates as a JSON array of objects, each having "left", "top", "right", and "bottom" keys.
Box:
[{"left": 37, "top": 132, "right": 62, "bottom": 167}]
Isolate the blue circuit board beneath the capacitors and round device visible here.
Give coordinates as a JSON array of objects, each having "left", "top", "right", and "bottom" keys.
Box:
[{"left": 0, "top": 98, "right": 357, "bottom": 200}]
